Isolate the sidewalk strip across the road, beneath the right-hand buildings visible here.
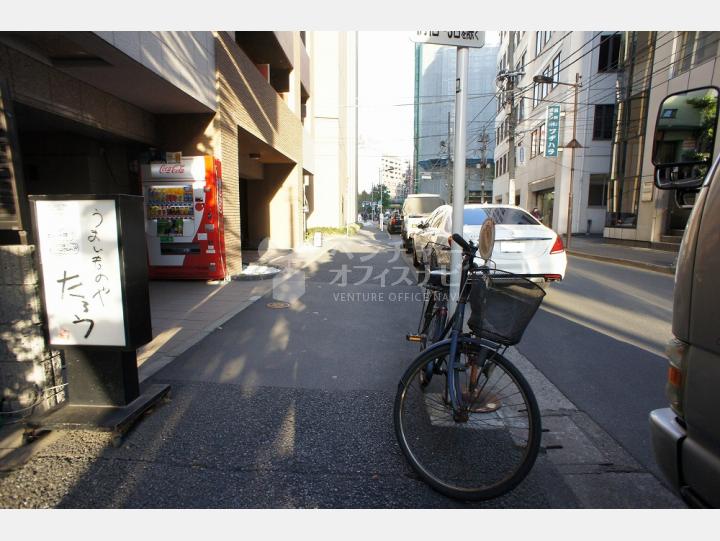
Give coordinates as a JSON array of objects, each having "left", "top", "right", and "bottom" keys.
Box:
[{"left": 568, "top": 236, "right": 677, "bottom": 274}]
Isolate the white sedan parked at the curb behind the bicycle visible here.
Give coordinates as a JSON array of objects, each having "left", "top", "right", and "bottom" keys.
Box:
[{"left": 413, "top": 200, "right": 567, "bottom": 282}]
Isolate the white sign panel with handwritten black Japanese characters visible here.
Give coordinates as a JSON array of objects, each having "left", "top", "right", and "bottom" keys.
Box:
[{"left": 35, "top": 199, "right": 125, "bottom": 346}]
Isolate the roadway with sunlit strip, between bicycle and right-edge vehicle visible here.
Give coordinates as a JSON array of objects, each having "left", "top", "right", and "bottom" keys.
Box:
[{"left": 518, "top": 256, "right": 673, "bottom": 478}]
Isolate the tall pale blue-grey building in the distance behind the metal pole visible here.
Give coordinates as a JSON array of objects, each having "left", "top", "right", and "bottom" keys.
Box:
[{"left": 414, "top": 40, "right": 498, "bottom": 201}]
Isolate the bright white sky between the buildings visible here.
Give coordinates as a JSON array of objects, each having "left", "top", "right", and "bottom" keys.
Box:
[{"left": 358, "top": 31, "right": 498, "bottom": 191}]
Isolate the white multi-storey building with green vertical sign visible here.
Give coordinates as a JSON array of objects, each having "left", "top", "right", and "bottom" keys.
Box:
[{"left": 493, "top": 31, "right": 620, "bottom": 234}]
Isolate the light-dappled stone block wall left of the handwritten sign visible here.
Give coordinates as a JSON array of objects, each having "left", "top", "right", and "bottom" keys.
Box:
[{"left": 0, "top": 246, "right": 64, "bottom": 424}]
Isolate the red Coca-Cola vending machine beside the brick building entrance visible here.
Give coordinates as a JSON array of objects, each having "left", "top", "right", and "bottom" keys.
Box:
[{"left": 142, "top": 156, "right": 226, "bottom": 280}]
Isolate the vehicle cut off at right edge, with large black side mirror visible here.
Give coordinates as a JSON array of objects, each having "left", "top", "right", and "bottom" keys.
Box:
[{"left": 650, "top": 84, "right": 720, "bottom": 507}]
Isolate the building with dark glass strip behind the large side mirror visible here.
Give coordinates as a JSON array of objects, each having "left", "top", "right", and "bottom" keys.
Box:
[{"left": 603, "top": 31, "right": 720, "bottom": 249}]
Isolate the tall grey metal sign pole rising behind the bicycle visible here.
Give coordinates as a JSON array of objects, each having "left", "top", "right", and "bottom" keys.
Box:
[{"left": 450, "top": 47, "right": 470, "bottom": 310}]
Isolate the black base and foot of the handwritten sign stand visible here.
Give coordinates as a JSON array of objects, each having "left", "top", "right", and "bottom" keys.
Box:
[{"left": 25, "top": 348, "right": 170, "bottom": 446}]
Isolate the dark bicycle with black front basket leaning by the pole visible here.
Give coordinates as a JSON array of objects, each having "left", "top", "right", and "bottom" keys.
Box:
[{"left": 393, "top": 234, "right": 545, "bottom": 500}]
